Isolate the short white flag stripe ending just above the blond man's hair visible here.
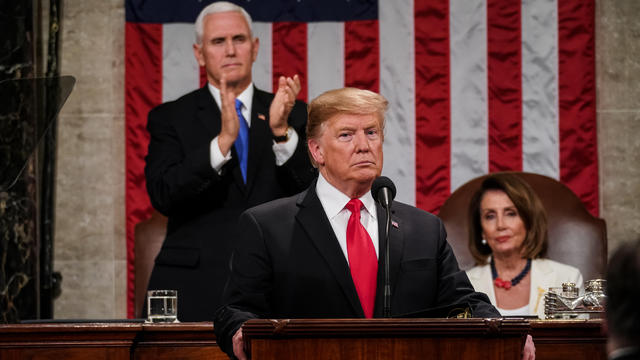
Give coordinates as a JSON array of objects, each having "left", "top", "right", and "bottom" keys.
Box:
[{"left": 307, "top": 22, "right": 344, "bottom": 102}]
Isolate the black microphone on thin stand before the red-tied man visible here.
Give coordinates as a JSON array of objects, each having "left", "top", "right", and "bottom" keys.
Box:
[{"left": 371, "top": 176, "right": 396, "bottom": 318}]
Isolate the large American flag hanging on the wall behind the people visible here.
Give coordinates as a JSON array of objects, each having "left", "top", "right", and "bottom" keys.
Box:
[{"left": 125, "top": 0, "right": 598, "bottom": 316}]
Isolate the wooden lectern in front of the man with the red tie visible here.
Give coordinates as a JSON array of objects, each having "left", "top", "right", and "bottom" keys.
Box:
[{"left": 242, "top": 319, "right": 530, "bottom": 360}]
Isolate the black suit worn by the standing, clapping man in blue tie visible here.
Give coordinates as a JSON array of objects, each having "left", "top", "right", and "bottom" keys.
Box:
[{"left": 145, "top": 86, "right": 315, "bottom": 321}]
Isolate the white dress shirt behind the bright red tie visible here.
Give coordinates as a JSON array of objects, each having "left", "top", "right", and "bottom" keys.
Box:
[{"left": 316, "top": 174, "right": 378, "bottom": 263}]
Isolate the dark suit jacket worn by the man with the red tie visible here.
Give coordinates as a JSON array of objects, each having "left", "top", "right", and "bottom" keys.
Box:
[{"left": 214, "top": 183, "right": 499, "bottom": 352}]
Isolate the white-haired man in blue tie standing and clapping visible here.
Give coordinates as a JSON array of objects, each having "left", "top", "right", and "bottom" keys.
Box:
[{"left": 145, "top": 2, "right": 315, "bottom": 321}]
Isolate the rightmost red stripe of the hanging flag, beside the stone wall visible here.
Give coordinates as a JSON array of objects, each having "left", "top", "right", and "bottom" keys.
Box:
[{"left": 558, "top": 1, "right": 599, "bottom": 216}]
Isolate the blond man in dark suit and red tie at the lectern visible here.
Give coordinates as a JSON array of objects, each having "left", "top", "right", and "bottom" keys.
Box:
[{"left": 214, "top": 88, "right": 499, "bottom": 359}]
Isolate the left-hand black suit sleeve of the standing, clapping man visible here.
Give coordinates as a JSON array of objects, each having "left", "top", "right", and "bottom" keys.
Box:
[{"left": 145, "top": 105, "right": 220, "bottom": 215}]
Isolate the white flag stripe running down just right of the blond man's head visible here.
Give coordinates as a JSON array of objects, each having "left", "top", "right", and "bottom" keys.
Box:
[{"left": 378, "top": 0, "right": 416, "bottom": 205}]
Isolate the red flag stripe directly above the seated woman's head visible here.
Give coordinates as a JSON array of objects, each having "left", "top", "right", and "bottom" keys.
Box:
[{"left": 487, "top": 0, "right": 522, "bottom": 172}]
